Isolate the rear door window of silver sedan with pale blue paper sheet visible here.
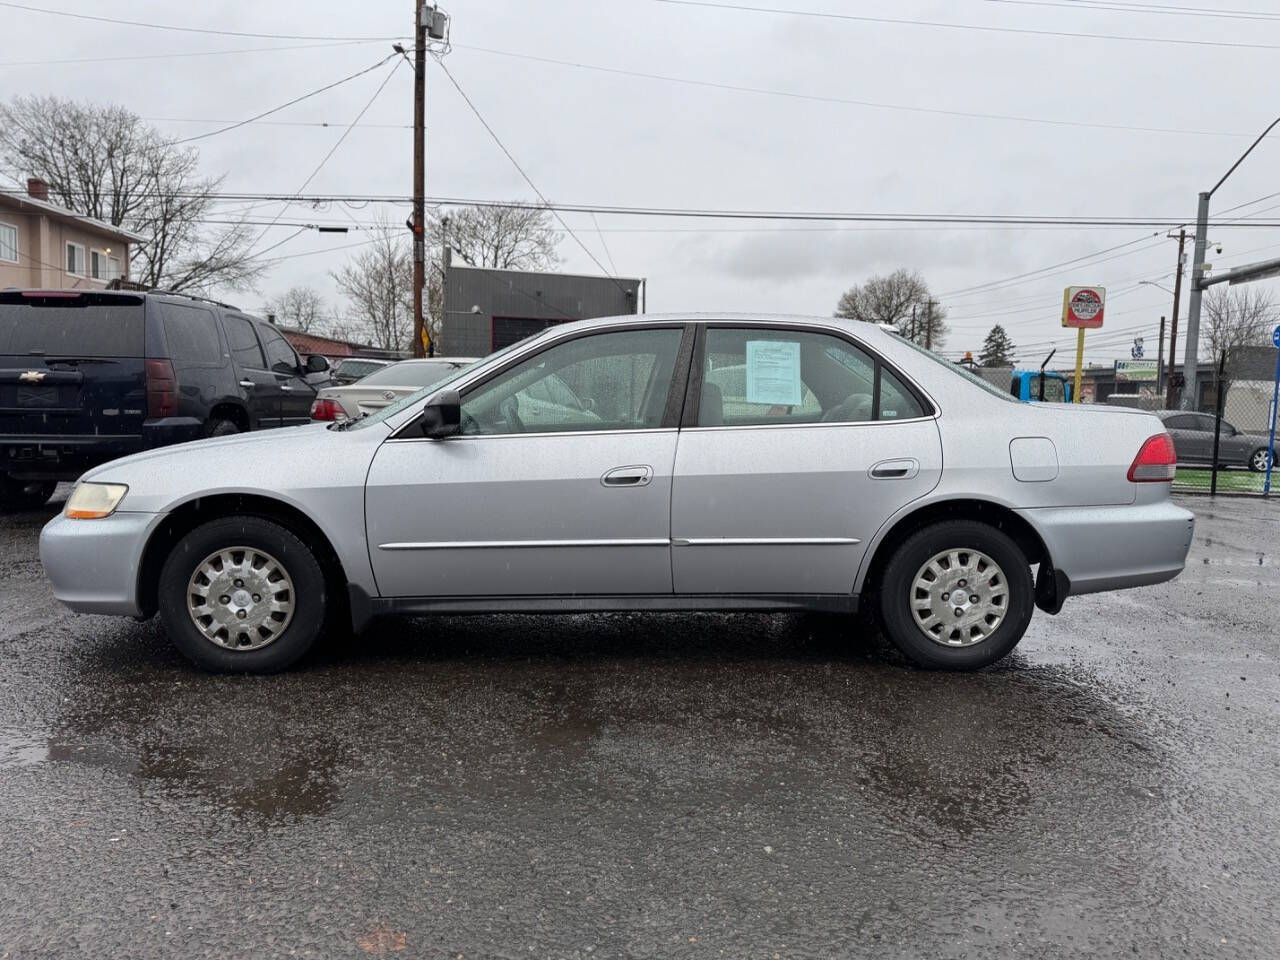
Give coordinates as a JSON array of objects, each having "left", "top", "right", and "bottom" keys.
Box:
[{"left": 698, "top": 326, "right": 923, "bottom": 426}]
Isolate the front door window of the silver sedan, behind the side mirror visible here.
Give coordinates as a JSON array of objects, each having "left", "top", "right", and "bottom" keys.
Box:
[{"left": 462, "top": 328, "right": 682, "bottom": 435}]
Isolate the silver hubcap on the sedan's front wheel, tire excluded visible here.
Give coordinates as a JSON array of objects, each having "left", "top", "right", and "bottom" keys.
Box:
[{"left": 187, "top": 547, "right": 294, "bottom": 650}]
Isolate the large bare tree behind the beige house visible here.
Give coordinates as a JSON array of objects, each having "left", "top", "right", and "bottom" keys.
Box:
[{"left": 0, "top": 96, "right": 264, "bottom": 291}]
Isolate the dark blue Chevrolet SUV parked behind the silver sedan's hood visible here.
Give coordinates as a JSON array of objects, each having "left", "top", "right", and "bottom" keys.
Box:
[{"left": 0, "top": 289, "right": 329, "bottom": 508}]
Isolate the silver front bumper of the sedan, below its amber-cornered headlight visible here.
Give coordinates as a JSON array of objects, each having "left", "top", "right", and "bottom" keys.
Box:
[{"left": 40, "top": 512, "right": 163, "bottom": 617}]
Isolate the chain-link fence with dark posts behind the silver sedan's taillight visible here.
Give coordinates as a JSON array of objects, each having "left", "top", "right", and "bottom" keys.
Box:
[{"left": 1162, "top": 349, "right": 1280, "bottom": 495}]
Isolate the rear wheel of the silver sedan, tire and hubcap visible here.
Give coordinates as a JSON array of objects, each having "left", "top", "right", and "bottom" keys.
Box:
[{"left": 879, "top": 520, "right": 1034, "bottom": 669}]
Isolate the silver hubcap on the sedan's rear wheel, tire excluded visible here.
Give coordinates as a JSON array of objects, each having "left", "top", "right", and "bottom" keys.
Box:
[{"left": 911, "top": 548, "right": 1009, "bottom": 646}]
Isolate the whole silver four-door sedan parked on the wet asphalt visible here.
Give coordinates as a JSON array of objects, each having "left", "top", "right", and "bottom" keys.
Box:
[{"left": 40, "top": 316, "right": 1194, "bottom": 672}]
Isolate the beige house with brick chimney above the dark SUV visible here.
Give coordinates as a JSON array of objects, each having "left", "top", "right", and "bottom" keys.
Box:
[{"left": 0, "top": 179, "right": 143, "bottom": 291}]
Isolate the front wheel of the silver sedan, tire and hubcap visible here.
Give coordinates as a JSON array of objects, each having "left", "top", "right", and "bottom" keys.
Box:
[{"left": 159, "top": 517, "right": 332, "bottom": 673}]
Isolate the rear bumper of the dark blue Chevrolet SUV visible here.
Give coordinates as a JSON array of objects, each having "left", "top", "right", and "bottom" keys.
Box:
[{"left": 0, "top": 417, "right": 205, "bottom": 480}]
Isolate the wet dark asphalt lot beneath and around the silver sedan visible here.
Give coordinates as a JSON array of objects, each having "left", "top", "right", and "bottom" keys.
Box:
[{"left": 0, "top": 499, "right": 1280, "bottom": 957}]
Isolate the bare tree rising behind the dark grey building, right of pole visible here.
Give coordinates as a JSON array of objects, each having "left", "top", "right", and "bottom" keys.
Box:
[{"left": 428, "top": 206, "right": 561, "bottom": 270}]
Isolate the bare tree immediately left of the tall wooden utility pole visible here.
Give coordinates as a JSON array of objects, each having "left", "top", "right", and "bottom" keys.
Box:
[{"left": 330, "top": 219, "right": 413, "bottom": 351}]
